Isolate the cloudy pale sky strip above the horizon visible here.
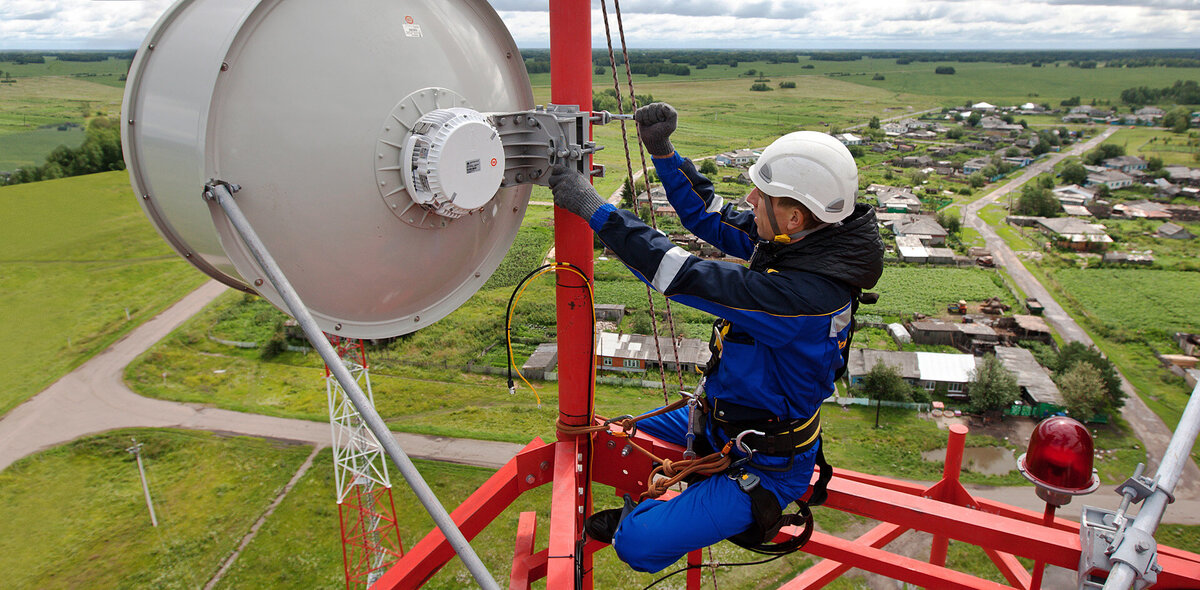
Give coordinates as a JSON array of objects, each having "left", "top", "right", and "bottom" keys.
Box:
[{"left": 0, "top": 0, "right": 1200, "bottom": 49}]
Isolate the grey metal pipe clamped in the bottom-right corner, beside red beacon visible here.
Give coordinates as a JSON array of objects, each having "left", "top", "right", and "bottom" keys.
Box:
[{"left": 1104, "top": 384, "right": 1200, "bottom": 590}]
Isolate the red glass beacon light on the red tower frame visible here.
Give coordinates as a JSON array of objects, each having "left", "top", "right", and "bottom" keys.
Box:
[{"left": 1016, "top": 416, "right": 1100, "bottom": 506}]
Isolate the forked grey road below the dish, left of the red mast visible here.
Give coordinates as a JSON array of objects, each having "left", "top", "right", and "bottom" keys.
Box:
[{"left": 0, "top": 281, "right": 521, "bottom": 470}]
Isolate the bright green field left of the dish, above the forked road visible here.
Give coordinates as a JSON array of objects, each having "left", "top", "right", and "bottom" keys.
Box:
[{"left": 0, "top": 171, "right": 204, "bottom": 414}]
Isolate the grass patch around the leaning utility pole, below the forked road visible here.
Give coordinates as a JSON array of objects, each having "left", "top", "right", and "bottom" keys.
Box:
[{"left": 0, "top": 429, "right": 314, "bottom": 589}]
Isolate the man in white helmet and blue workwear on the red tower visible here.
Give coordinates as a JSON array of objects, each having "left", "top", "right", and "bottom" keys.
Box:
[{"left": 550, "top": 103, "right": 883, "bottom": 572}]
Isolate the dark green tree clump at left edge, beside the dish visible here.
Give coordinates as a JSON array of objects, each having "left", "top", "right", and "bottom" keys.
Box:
[{"left": 0, "top": 116, "right": 125, "bottom": 185}]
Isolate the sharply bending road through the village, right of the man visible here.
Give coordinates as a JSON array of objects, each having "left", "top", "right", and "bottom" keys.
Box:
[{"left": 964, "top": 128, "right": 1200, "bottom": 498}]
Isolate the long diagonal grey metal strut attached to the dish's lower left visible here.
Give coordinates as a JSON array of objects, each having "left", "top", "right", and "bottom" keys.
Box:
[{"left": 204, "top": 183, "right": 499, "bottom": 590}]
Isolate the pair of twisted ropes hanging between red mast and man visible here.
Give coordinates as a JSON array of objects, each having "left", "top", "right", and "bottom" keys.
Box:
[{"left": 600, "top": 0, "right": 684, "bottom": 404}]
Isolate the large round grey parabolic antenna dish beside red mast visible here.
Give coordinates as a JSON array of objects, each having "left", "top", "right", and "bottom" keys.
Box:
[{"left": 122, "top": 0, "right": 534, "bottom": 338}]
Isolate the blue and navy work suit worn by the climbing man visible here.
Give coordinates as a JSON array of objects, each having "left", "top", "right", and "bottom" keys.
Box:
[{"left": 588, "top": 152, "right": 883, "bottom": 572}]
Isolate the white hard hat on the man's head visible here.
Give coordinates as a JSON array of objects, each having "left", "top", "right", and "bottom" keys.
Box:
[{"left": 750, "top": 131, "right": 858, "bottom": 223}]
